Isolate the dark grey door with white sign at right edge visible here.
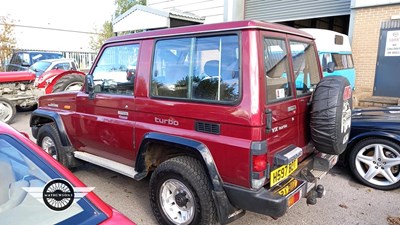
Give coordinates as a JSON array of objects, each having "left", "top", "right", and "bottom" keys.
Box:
[{"left": 373, "top": 21, "right": 400, "bottom": 98}]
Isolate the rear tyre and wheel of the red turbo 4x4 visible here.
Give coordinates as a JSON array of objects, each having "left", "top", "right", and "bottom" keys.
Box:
[{"left": 150, "top": 156, "right": 217, "bottom": 225}]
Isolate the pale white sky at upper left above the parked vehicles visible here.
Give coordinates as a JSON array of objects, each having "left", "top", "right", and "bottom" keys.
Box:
[{"left": 0, "top": 0, "right": 115, "bottom": 52}]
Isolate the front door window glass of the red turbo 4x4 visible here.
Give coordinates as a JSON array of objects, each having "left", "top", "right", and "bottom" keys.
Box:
[{"left": 93, "top": 44, "right": 139, "bottom": 95}]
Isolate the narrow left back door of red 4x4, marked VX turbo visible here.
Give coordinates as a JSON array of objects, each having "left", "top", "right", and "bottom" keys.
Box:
[{"left": 262, "top": 32, "right": 299, "bottom": 186}]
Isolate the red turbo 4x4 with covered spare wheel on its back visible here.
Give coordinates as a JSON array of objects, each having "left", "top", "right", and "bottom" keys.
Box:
[{"left": 30, "top": 21, "right": 351, "bottom": 224}]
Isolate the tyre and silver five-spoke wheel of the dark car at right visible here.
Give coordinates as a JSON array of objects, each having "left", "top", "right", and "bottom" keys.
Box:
[{"left": 348, "top": 138, "right": 400, "bottom": 190}]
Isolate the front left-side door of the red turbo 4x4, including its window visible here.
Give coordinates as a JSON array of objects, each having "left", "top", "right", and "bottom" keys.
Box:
[{"left": 73, "top": 43, "right": 139, "bottom": 166}]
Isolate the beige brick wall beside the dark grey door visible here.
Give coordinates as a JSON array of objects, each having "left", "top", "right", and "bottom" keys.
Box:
[{"left": 352, "top": 5, "right": 400, "bottom": 102}]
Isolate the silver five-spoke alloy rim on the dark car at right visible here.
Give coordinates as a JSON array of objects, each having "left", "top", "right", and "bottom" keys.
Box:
[{"left": 355, "top": 144, "right": 400, "bottom": 186}]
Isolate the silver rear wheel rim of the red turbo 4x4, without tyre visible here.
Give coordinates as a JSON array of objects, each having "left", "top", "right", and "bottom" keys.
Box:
[{"left": 160, "top": 179, "right": 195, "bottom": 225}]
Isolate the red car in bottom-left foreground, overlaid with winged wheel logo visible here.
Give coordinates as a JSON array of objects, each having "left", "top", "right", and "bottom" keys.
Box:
[{"left": 0, "top": 122, "right": 135, "bottom": 225}]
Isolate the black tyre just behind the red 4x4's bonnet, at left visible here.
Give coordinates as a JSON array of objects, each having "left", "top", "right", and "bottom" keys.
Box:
[{"left": 52, "top": 73, "right": 85, "bottom": 93}]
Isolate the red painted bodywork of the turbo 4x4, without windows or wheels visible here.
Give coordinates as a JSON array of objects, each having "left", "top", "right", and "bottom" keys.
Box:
[{"left": 36, "top": 21, "right": 318, "bottom": 187}]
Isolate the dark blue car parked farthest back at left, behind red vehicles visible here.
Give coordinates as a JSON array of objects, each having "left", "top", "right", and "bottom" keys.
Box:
[{"left": 6, "top": 51, "right": 63, "bottom": 72}]
